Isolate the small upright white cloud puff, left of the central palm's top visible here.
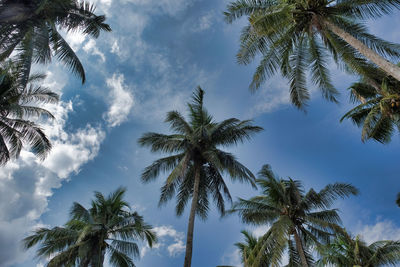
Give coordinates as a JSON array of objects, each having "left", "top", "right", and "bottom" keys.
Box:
[{"left": 104, "top": 73, "right": 134, "bottom": 127}]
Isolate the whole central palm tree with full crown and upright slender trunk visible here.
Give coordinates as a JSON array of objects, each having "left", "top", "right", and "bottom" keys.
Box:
[{"left": 139, "top": 87, "right": 262, "bottom": 267}]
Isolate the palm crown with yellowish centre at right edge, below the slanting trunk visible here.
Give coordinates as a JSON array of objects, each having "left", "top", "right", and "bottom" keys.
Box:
[{"left": 340, "top": 66, "right": 400, "bottom": 143}]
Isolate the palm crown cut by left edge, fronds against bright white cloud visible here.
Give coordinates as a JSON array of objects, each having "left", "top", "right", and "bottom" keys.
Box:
[{"left": 0, "top": 62, "right": 58, "bottom": 165}]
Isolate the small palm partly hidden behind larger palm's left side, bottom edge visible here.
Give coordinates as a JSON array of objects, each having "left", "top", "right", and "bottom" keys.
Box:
[{"left": 235, "top": 230, "right": 269, "bottom": 267}]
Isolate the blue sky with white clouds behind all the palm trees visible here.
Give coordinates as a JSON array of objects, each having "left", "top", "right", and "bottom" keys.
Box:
[{"left": 0, "top": 0, "right": 400, "bottom": 267}]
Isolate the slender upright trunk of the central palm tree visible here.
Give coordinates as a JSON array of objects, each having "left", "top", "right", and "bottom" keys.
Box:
[{"left": 183, "top": 167, "right": 200, "bottom": 267}]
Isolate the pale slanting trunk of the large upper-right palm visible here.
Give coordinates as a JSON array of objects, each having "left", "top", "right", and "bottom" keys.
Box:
[{"left": 323, "top": 20, "right": 400, "bottom": 81}]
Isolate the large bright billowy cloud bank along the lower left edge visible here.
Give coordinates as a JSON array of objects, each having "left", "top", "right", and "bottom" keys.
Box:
[{"left": 0, "top": 73, "right": 105, "bottom": 266}]
